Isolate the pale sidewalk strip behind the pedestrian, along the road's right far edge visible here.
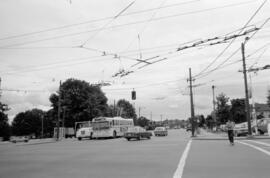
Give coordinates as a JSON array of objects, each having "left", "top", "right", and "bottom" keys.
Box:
[{"left": 192, "top": 129, "right": 270, "bottom": 140}]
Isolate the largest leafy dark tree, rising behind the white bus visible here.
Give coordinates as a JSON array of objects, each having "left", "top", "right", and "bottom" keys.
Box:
[{"left": 50, "top": 79, "right": 108, "bottom": 127}]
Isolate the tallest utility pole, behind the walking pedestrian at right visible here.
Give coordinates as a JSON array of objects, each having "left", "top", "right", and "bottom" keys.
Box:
[{"left": 241, "top": 41, "right": 251, "bottom": 135}]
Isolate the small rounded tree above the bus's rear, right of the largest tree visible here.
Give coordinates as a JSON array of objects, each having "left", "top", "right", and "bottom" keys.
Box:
[{"left": 117, "top": 99, "right": 137, "bottom": 119}]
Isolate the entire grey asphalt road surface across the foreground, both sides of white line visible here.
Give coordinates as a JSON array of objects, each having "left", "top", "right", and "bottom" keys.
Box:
[{"left": 0, "top": 130, "right": 270, "bottom": 178}]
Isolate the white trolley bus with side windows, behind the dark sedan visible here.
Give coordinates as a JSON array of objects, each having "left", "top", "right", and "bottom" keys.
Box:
[{"left": 92, "top": 117, "right": 134, "bottom": 138}]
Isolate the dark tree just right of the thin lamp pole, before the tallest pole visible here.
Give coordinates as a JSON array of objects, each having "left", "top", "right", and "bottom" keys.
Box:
[{"left": 216, "top": 93, "right": 230, "bottom": 124}]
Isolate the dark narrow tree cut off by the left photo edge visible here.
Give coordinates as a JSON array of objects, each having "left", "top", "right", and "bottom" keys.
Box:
[{"left": 0, "top": 102, "right": 10, "bottom": 140}]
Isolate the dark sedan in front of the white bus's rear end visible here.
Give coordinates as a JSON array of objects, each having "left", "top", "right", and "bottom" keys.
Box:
[{"left": 124, "top": 126, "right": 152, "bottom": 141}]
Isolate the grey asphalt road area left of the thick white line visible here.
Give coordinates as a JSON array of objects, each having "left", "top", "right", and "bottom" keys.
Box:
[{"left": 0, "top": 130, "right": 189, "bottom": 178}]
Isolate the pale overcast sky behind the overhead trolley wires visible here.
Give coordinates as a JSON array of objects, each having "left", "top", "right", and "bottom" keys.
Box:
[{"left": 0, "top": 0, "right": 270, "bottom": 120}]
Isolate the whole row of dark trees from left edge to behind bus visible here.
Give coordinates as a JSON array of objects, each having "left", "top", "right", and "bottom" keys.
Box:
[{"left": 0, "top": 79, "right": 140, "bottom": 140}]
